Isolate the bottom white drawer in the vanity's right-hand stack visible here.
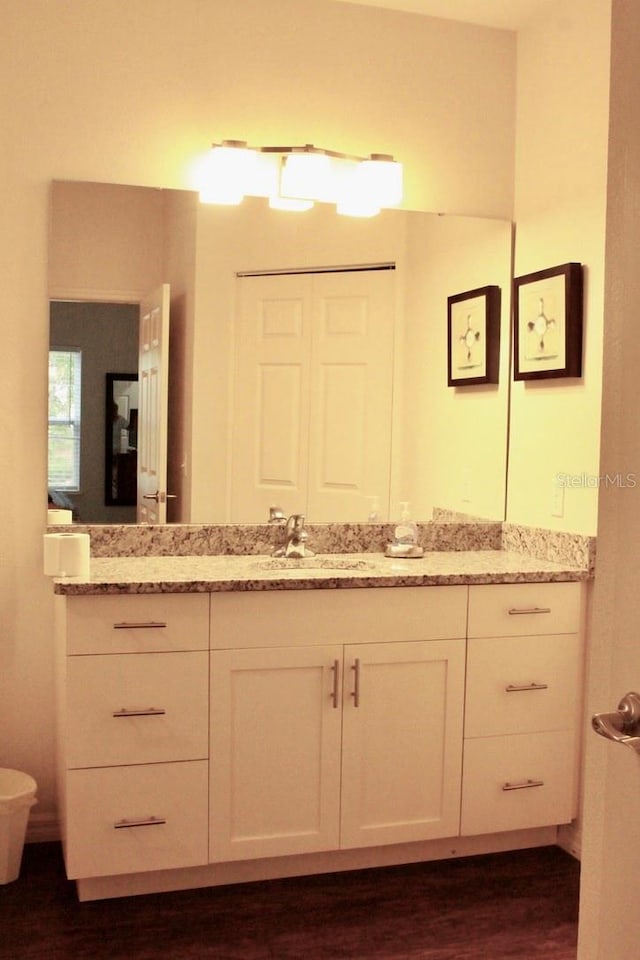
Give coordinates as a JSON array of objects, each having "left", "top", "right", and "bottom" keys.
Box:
[{"left": 460, "top": 731, "right": 576, "bottom": 836}]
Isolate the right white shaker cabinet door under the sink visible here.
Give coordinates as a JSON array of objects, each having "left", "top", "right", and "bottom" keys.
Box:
[{"left": 341, "top": 640, "right": 465, "bottom": 847}]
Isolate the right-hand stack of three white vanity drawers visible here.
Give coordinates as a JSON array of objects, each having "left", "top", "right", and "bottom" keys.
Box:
[{"left": 461, "top": 583, "right": 583, "bottom": 836}]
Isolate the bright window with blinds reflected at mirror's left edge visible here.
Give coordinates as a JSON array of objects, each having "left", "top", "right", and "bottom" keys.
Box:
[{"left": 49, "top": 347, "right": 82, "bottom": 492}]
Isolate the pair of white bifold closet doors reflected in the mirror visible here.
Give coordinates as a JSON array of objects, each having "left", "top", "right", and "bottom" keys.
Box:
[{"left": 231, "top": 270, "right": 394, "bottom": 523}]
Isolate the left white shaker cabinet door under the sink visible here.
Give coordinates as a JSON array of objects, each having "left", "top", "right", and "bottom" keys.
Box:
[{"left": 210, "top": 645, "right": 342, "bottom": 862}]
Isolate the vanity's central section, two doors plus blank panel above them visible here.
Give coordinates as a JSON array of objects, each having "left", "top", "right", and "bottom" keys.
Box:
[{"left": 210, "top": 586, "right": 467, "bottom": 862}]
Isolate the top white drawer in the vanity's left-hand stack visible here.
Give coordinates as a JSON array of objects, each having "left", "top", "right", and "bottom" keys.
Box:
[{"left": 66, "top": 593, "right": 209, "bottom": 655}]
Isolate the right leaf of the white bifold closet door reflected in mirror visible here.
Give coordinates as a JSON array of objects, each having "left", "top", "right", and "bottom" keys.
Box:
[{"left": 307, "top": 270, "right": 394, "bottom": 521}]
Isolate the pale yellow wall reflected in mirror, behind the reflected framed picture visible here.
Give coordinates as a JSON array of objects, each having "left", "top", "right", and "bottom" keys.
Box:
[{"left": 399, "top": 217, "right": 512, "bottom": 520}]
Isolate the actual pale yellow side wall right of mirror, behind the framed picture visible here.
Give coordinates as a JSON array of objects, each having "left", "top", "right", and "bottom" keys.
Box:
[{"left": 507, "top": 0, "right": 611, "bottom": 534}]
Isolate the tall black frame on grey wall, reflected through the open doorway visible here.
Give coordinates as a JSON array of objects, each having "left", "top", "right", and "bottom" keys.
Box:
[{"left": 104, "top": 373, "right": 138, "bottom": 507}]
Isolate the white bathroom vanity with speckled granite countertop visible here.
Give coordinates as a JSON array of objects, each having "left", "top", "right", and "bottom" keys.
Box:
[{"left": 55, "top": 551, "right": 586, "bottom": 899}]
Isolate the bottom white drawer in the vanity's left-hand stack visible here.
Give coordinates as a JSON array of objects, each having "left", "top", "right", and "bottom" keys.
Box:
[{"left": 65, "top": 760, "right": 208, "bottom": 879}]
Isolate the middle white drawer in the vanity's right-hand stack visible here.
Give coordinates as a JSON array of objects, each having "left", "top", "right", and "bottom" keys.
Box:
[{"left": 465, "top": 633, "right": 582, "bottom": 737}]
